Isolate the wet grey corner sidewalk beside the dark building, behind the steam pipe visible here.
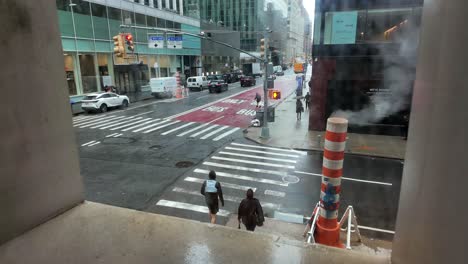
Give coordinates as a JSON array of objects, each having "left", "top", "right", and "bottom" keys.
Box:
[{"left": 244, "top": 94, "right": 406, "bottom": 159}]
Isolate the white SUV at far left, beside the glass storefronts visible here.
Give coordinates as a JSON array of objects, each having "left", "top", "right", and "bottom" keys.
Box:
[{"left": 81, "top": 92, "right": 130, "bottom": 113}]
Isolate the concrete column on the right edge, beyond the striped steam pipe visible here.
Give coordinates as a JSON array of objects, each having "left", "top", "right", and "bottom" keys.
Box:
[{"left": 392, "top": 0, "right": 468, "bottom": 264}]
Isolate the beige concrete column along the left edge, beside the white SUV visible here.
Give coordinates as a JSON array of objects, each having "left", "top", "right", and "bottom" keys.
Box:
[{"left": 0, "top": 0, "right": 83, "bottom": 244}]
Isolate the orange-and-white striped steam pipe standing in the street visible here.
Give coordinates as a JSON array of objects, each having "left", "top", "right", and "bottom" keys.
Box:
[{"left": 315, "top": 117, "right": 348, "bottom": 248}]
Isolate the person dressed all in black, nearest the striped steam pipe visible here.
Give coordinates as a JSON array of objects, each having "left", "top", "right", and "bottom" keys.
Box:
[{"left": 237, "top": 189, "right": 265, "bottom": 231}]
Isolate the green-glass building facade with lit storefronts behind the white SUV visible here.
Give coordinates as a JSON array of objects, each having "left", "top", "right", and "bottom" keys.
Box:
[{"left": 56, "top": 0, "right": 201, "bottom": 99}]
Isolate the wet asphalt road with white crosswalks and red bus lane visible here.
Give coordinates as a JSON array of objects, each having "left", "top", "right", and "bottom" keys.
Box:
[{"left": 73, "top": 77, "right": 403, "bottom": 239}]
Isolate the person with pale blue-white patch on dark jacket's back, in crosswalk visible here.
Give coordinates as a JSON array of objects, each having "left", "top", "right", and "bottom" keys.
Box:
[{"left": 200, "top": 170, "right": 224, "bottom": 224}]
